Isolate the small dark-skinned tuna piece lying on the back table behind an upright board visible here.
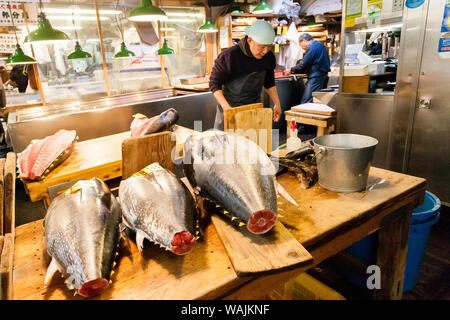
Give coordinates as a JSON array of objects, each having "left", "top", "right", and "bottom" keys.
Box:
[{"left": 130, "top": 108, "right": 179, "bottom": 137}]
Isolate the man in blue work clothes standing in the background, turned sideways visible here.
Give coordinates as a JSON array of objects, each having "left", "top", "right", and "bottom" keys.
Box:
[{"left": 286, "top": 33, "right": 331, "bottom": 103}]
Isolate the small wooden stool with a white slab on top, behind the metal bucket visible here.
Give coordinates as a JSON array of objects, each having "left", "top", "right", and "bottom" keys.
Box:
[{"left": 284, "top": 111, "right": 336, "bottom": 138}]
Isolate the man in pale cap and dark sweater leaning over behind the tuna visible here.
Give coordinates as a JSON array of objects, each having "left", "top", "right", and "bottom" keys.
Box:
[{"left": 209, "top": 20, "right": 281, "bottom": 130}]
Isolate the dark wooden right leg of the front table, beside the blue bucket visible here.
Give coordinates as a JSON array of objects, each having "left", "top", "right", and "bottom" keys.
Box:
[{"left": 374, "top": 204, "right": 413, "bottom": 300}]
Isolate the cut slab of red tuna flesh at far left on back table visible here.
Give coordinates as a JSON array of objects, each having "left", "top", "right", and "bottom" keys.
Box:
[{"left": 17, "top": 130, "right": 77, "bottom": 182}]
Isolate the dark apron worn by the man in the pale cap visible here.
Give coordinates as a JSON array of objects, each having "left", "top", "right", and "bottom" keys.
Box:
[{"left": 214, "top": 70, "right": 266, "bottom": 130}]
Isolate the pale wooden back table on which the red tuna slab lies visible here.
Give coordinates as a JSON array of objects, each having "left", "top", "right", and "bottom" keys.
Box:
[{"left": 25, "top": 126, "right": 193, "bottom": 203}]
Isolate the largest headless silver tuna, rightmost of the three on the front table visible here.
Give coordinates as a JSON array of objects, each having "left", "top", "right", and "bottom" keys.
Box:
[{"left": 183, "top": 131, "right": 278, "bottom": 234}]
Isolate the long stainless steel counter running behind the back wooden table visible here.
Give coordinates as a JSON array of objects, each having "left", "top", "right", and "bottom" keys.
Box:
[{"left": 7, "top": 92, "right": 216, "bottom": 157}]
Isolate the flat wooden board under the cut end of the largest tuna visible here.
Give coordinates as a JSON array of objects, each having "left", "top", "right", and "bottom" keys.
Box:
[{"left": 211, "top": 215, "right": 313, "bottom": 277}]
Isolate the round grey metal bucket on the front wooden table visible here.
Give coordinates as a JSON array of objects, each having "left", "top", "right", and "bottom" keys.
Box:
[{"left": 314, "top": 134, "right": 378, "bottom": 192}]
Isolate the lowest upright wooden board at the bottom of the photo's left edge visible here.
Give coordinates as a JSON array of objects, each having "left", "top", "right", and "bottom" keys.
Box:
[{"left": 0, "top": 233, "right": 14, "bottom": 300}]
